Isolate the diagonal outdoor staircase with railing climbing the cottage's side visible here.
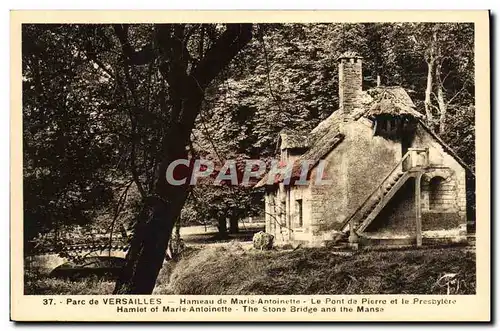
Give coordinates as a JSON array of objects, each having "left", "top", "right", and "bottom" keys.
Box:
[{"left": 342, "top": 149, "right": 428, "bottom": 235}]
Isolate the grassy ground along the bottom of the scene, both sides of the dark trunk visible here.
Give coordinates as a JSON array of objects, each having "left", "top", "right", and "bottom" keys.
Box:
[{"left": 25, "top": 241, "right": 476, "bottom": 295}]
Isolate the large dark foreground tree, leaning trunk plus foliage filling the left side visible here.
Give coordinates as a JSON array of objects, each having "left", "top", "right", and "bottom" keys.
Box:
[{"left": 23, "top": 24, "right": 253, "bottom": 294}]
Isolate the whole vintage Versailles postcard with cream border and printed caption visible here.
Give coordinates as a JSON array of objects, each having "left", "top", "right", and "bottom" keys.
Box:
[{"left": 10, "top": 11, "right": 491, "bottom": 322}]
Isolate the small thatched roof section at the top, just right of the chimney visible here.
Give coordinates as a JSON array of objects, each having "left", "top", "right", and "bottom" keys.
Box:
[{"left": 365, "top": 86, "right": 423, "bottom": 118}]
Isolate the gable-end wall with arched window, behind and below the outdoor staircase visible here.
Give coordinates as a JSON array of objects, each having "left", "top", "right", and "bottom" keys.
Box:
[{"left": 366, "top": 124, "right": 466, "bottom": 242}]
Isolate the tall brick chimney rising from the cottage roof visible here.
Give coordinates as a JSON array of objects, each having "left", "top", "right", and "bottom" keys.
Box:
[{"left": 338, "top": 52, "right": 363, "bottom": 120}]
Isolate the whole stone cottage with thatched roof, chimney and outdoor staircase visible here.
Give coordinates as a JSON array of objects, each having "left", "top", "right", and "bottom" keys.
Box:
[{"left": 257, "top": 53, "right": 471, "bottom": 245}]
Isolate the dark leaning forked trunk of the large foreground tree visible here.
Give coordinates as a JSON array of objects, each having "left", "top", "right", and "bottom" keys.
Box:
[{"left": 114, "top": 24, "right": 252, "bottom": 294}]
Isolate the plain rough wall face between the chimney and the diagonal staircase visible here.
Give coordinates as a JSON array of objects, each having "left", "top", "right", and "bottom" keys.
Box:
[{"left": 304, "top": 119, "right": 401, "bottom": 242}]
